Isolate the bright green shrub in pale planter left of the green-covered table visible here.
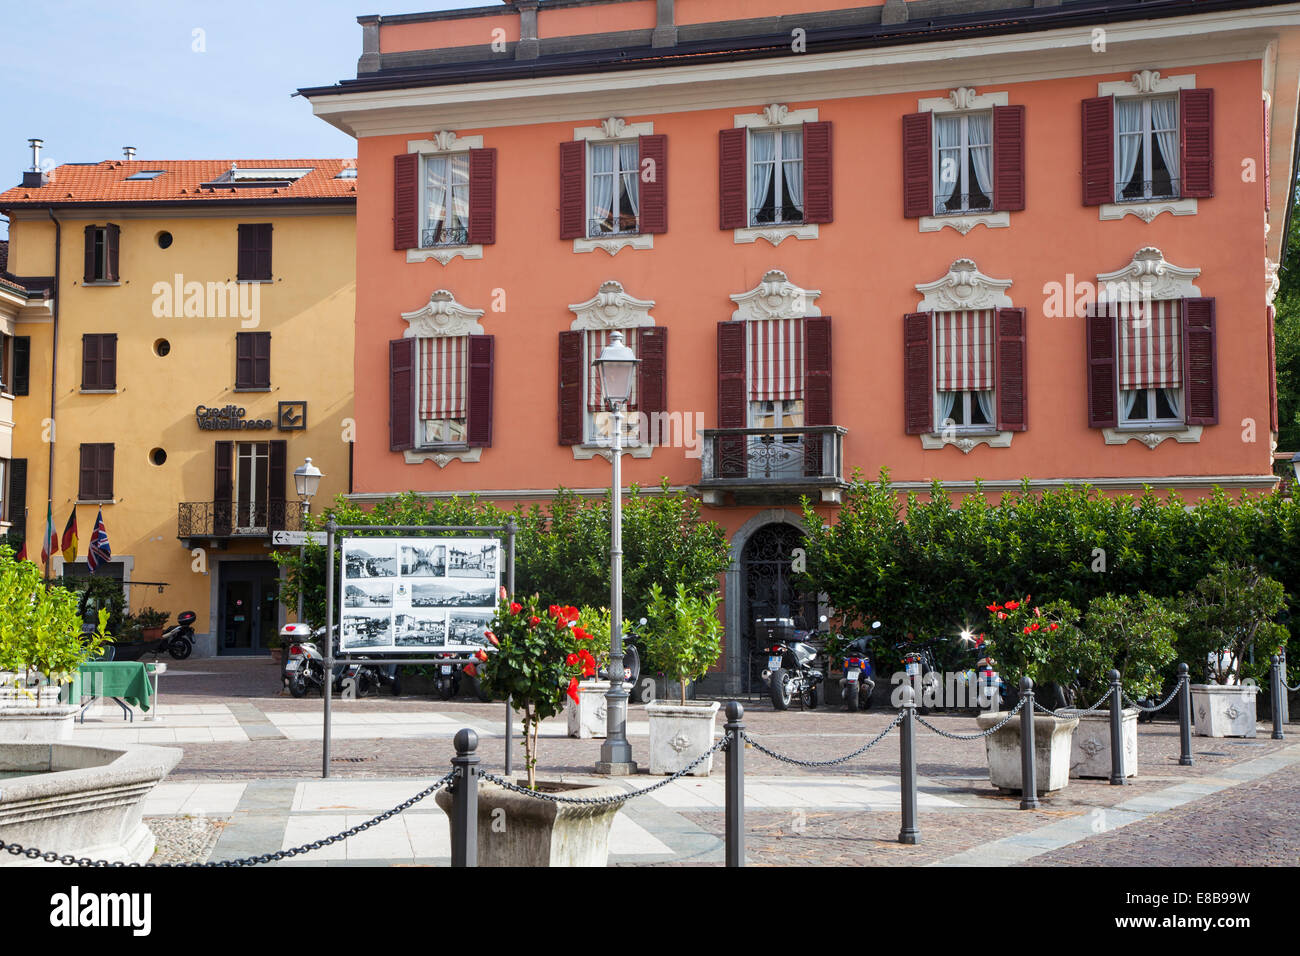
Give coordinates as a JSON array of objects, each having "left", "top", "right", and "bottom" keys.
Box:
[{"left": 0, "top": 546, "right": 108, "bottom": 743}]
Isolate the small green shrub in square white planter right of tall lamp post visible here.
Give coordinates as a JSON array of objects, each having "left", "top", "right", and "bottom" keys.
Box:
[{"left": 644, "top": 584, "right": 723, "bottom": 777}]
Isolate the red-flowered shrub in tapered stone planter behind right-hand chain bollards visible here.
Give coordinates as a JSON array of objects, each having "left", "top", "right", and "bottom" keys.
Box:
[{"left": 975, "top": 597, "right": 1079, "bottom": 793}]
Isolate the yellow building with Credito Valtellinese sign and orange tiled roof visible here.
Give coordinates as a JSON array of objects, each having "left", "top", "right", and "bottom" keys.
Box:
[{"left": 0, "top": 159, "right": 358, "bottom": 654}]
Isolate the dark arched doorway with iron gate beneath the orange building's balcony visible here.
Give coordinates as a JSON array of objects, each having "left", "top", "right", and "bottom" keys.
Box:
[{"left": 740, "top": 522, "right": 818, "bottom": 693}]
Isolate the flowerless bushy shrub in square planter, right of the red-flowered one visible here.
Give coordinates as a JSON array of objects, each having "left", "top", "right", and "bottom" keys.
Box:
[{"left": 1070, "top": 592, "right": 1187, "bottom": 779}]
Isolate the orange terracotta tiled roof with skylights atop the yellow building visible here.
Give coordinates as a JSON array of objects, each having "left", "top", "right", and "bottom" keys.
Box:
[{"left": 0, "top": 159, "right": 359, "bottom": 208}]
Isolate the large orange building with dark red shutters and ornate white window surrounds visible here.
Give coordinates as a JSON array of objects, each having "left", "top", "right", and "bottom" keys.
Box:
[{"left": 303, "top": 0, "right": 1300, "bottom": 689}]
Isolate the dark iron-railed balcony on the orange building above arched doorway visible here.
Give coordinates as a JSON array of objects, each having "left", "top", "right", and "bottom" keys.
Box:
[{"left": 698, "top": 425, "right": 848, "bottom": 505}]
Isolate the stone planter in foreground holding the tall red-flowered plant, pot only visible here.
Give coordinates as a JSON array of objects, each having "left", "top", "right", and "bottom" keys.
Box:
[{"left": 434, "top": 778, "right": 628, "bottom": 866}]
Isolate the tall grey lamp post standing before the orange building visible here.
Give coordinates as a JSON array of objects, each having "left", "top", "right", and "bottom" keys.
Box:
[{"left": 595, "top": 329, "right": 638, "bottom": 775}]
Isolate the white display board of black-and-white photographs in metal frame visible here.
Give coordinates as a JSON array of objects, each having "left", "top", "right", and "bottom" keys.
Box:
[{"left": 339, "top": 537, "right": 502, "bottom": 654}]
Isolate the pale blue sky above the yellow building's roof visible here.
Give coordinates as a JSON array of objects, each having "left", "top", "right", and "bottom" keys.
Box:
[{"left": 0, "top": 0, "right": 478, "bottom": 238}]
